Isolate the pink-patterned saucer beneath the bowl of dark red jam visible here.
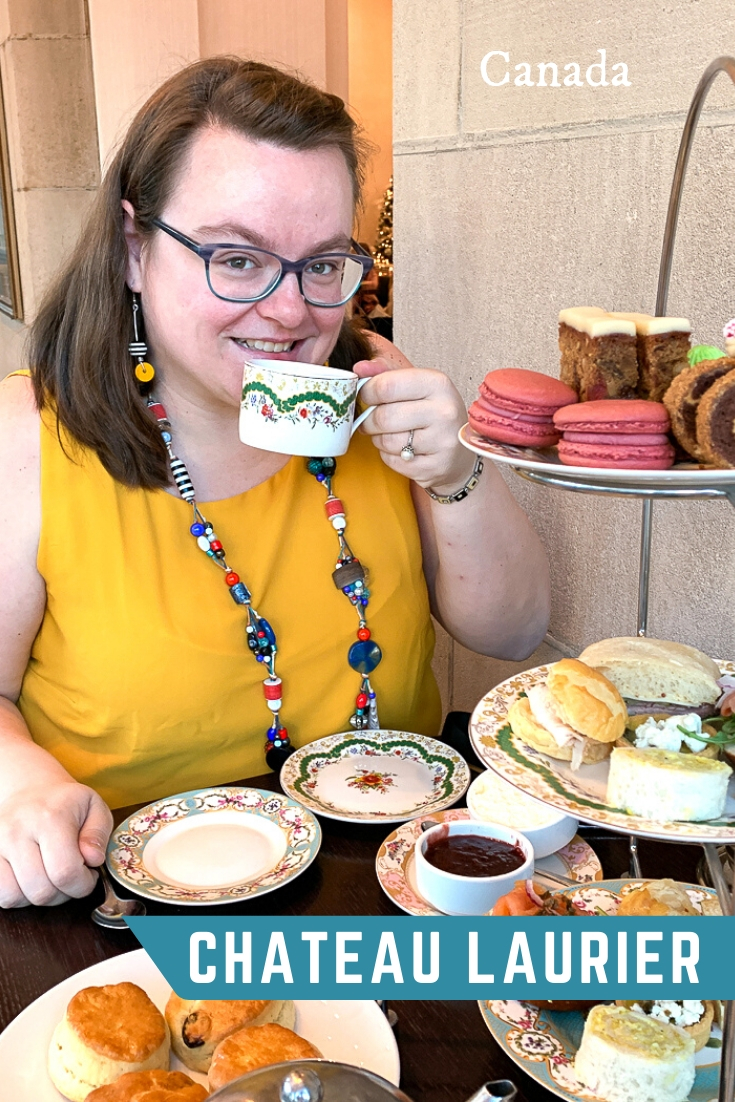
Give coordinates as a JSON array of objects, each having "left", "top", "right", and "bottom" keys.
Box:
[{"left": 375, "top": 808, "right": 603, "bottom": 918}]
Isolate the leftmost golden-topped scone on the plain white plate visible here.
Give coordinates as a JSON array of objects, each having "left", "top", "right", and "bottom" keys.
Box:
[{"left": 48, "top": 983, "right": 170, "bottom": 1102}]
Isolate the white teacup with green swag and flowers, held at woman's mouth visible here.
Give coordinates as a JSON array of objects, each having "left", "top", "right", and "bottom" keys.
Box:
[{"left": 240, "top": 359, "right": 375, "bottom": 455}]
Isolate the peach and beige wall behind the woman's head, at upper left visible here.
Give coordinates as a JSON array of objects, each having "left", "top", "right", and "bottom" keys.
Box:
[{"left": 0, "top": 0, "right": 392, "bottom": 378}]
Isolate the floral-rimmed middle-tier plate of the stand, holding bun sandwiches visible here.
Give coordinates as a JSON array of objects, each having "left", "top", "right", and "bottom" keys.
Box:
[{"left": 469, "top": 659, "right": 735, "bottom": 844}]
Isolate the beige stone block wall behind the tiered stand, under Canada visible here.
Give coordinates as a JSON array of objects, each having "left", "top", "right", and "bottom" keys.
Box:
[{"left": 393, "top": 0, "right": 735, "bottom": 709}]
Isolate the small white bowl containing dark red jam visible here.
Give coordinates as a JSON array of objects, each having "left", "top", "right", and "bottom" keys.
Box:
[{"left": 414, "top": 819, "right": 533, "bottom": 915}]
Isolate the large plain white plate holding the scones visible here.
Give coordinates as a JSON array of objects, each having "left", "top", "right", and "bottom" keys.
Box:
[{"left": 0, "top": 949, "right": 400, "bottom": 1102}]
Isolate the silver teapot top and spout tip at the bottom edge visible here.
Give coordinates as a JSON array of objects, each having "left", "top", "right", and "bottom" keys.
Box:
[{"left": 207, "top": 1060, "right": 516, "bottom": 1102}]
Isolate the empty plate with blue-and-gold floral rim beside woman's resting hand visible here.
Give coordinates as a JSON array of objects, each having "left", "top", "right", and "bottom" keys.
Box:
[{"left": 107, "top": 788, "right": 322, "bottom": 907}]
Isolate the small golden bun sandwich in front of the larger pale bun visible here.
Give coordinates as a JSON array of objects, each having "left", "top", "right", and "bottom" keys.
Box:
[{"left": 508, "top": 658, "right": 628, "bottom": 769}]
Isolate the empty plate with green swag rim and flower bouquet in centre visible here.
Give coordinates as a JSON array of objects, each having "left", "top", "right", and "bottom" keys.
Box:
[{"left": 280, "top": 731, "right": 469, "bottom": 823}]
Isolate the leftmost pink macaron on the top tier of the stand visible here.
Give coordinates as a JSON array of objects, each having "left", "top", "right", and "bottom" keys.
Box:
[{"left": 469, "top": 367, "right": 577, "bottom": 447}]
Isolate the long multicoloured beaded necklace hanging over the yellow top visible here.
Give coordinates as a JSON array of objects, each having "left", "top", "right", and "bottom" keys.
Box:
[{"left": 148, "top": 398, "right": 382, "bottom": 771}]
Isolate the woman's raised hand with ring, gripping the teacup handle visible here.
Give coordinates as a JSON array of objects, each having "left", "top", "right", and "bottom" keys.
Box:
[{"left": 354, "top": 342, "right": 475, "bottom": 494}]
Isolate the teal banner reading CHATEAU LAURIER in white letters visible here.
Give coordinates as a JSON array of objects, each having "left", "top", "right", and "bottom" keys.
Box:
[{"left": 129, "top": 916, "right": 735, "bottom": 1001}]
